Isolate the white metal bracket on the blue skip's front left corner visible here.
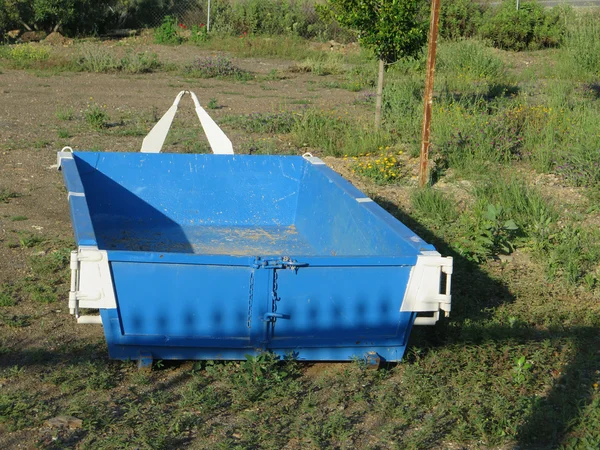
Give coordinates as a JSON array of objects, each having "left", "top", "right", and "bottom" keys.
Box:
[{"left": 69, "top": 246, "right": 117, "bottom": 324}]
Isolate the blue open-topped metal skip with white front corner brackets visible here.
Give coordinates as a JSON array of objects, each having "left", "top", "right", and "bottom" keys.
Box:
[{"left": 59, "top": 152, "right": 452, "bottom": 361}]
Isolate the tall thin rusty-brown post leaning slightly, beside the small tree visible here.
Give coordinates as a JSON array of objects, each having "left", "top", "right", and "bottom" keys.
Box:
[{"left": 419, "top": 0, "right": 440, "bottom": 187}]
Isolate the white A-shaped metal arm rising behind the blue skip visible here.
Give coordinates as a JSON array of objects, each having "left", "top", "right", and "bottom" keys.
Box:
[{"left": 141, "top": 91, "right": 233, "bottom": 155}]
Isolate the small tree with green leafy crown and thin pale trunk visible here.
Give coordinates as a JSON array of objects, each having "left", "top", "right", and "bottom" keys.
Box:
[{"left": 320, "top": 0, "right": 427, "bottom": 128}]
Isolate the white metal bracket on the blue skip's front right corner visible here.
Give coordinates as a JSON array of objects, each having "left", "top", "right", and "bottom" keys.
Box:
[{"left": 400, "top": 251, "right": 452, "bottom": 325}]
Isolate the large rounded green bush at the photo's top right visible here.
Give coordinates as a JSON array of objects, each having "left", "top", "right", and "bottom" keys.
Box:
[{"left": 480, "top": 0, "right": 565, "bottom": 51}]
